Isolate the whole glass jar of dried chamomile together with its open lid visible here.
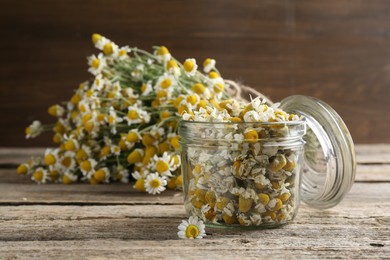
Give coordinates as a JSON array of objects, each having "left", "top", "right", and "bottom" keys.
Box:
[{"left": 179, "top": 96, "right": 356, "bottom": 228}]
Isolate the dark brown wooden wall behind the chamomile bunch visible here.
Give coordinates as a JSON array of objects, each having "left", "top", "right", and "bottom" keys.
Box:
[{"left": 0, "top": 0, "right": 390, "bottom": 146}]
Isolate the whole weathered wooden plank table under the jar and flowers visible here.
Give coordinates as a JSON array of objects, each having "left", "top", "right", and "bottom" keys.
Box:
[{"left": 0, "top": 145, "right": 390, "bottom": 259}]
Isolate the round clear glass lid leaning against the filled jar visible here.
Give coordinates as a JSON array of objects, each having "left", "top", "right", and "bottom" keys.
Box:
[{"left": 280, "top": 95, "right": 356, "bottom": 209}]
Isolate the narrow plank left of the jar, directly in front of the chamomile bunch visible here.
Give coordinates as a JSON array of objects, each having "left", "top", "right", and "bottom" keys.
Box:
[{"left": 0, "top": 183, "right": 183, "bottom": 205}]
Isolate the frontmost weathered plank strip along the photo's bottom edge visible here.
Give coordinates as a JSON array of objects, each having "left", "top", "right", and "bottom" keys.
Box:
[{"left": 0, "top": 240, "right": 390, "bottom": 260}]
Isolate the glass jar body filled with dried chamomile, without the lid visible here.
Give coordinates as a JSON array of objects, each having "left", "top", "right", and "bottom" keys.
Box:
[{"left": 179, "top": 121, "right": 306, "bottom": 228}]
